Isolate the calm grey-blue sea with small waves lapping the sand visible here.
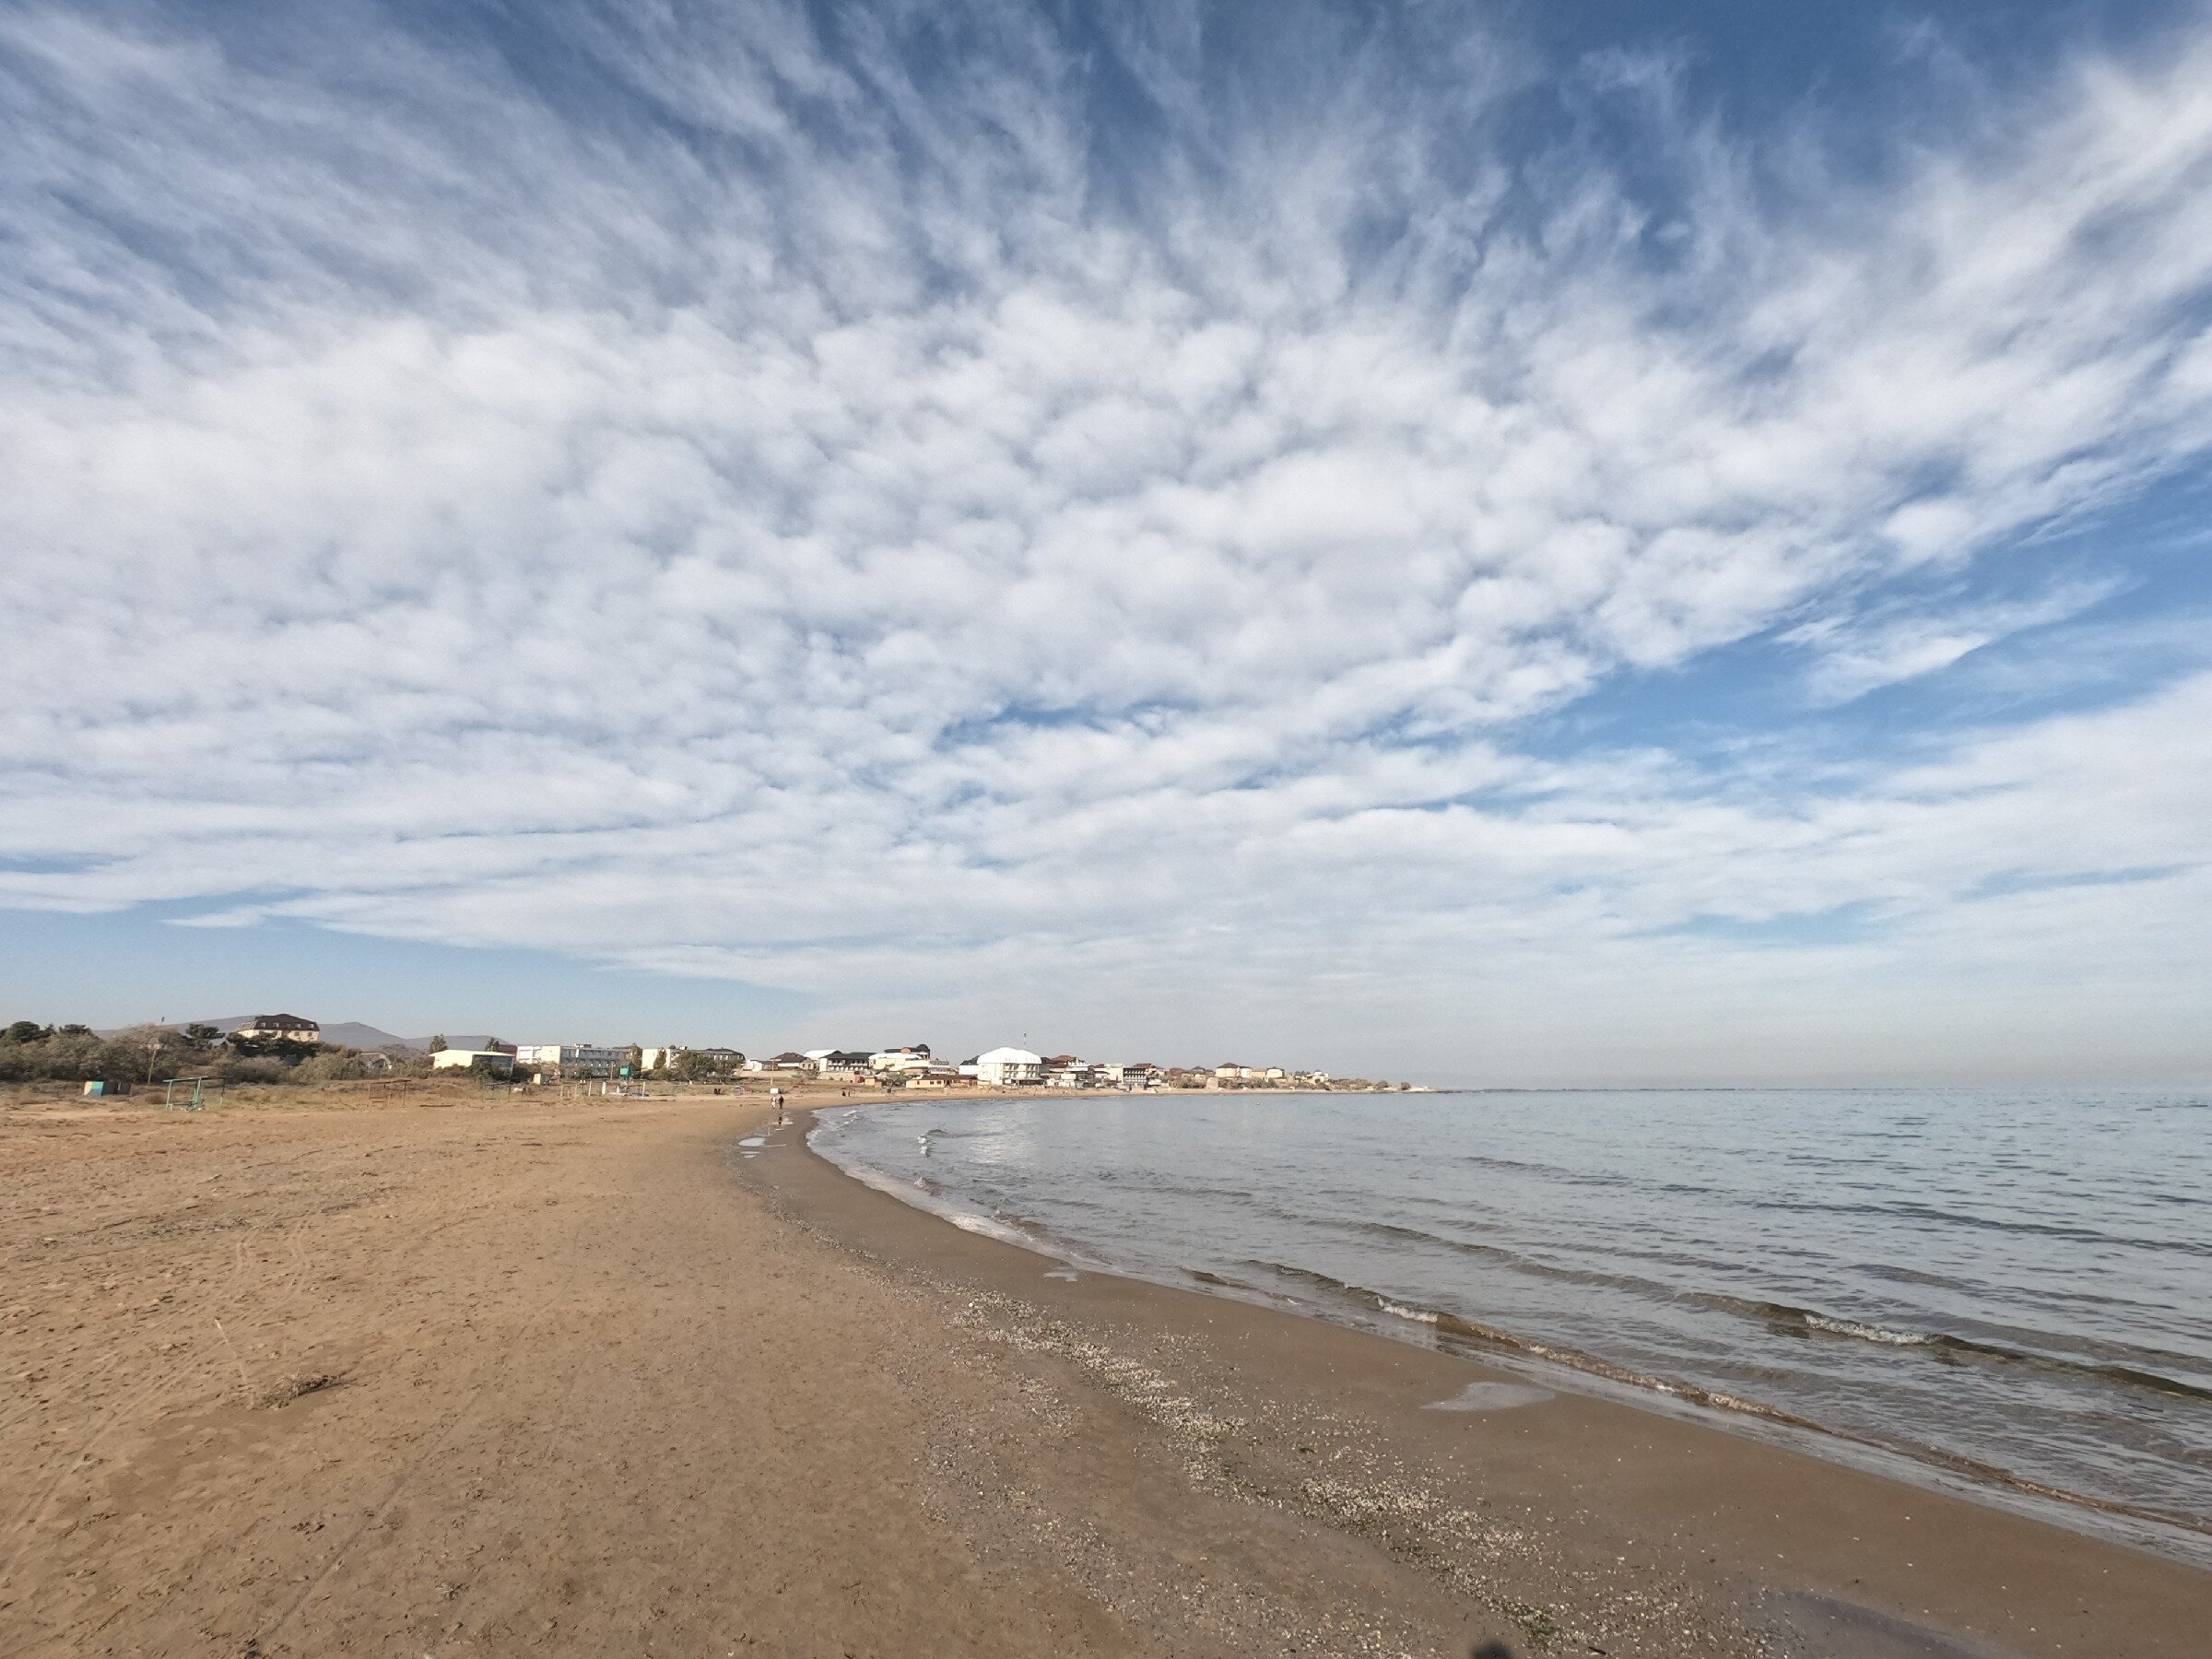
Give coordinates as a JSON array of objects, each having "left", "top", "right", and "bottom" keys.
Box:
[{"left": 814, "top": 1090, "right": 2212, "bottom": 1564}]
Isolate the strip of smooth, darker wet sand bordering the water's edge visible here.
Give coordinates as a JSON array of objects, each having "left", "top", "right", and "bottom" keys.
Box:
[{"left": 747, "top": 1101, "right": 2212, "bottom": 1654}]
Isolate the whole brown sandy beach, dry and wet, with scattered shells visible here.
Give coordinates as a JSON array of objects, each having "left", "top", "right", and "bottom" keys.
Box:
[{"left": 0, "top": 1090, "right": 2212, "bottom": 1659}]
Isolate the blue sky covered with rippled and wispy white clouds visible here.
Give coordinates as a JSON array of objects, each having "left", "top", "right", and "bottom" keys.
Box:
[{"left": 0, "top": 0, "right": 2212, "bottom": 1084}]
